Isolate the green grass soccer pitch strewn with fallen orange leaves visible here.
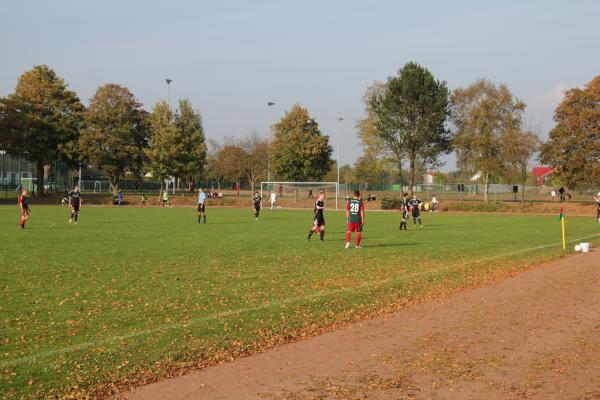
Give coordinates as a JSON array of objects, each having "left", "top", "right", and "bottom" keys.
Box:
[{"left": 0, "top": 206, "right": 599, "bottom": 398}]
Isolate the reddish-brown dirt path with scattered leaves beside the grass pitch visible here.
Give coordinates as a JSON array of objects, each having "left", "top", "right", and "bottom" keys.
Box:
[{"left": 120, "top": 251, "right": 600, "bottom": 400}]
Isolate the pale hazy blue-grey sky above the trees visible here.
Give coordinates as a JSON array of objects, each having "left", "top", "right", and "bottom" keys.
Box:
[{"left": 0, "top": 0, "right": 600, "bottom": 170}]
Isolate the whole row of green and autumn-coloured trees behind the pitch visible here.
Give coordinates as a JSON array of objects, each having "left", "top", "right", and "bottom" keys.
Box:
[{"left": 0, "top": 62, "right": 600, "bottom": 199}]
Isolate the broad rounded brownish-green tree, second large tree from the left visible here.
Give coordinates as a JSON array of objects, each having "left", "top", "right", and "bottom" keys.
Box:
[{"left": 79, "top": 83, "right": 149, "bottom": 194}]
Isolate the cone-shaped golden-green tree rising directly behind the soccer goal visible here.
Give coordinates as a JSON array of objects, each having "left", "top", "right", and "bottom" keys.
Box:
[{"left": 269, "top": 105, "right": 333, "bottom": 182}]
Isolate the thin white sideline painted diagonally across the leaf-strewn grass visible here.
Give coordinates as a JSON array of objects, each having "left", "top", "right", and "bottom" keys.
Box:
[{"left": 2, "top": 234, "right": 598, "bottom": 368}]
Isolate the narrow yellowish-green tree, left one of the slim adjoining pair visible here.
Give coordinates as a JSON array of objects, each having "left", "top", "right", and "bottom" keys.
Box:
[{"left": 145, "top": 101, "right": 180, "bottom": 196}]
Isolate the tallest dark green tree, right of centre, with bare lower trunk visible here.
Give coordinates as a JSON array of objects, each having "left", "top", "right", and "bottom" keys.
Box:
[{"left": 370, "top": 62, "right": 452, "bottom": 193}]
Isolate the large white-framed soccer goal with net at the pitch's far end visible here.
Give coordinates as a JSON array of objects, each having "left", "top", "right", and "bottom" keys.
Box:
[{"left": 260, "top": 182, "right": 346, "bottom": 210}]
